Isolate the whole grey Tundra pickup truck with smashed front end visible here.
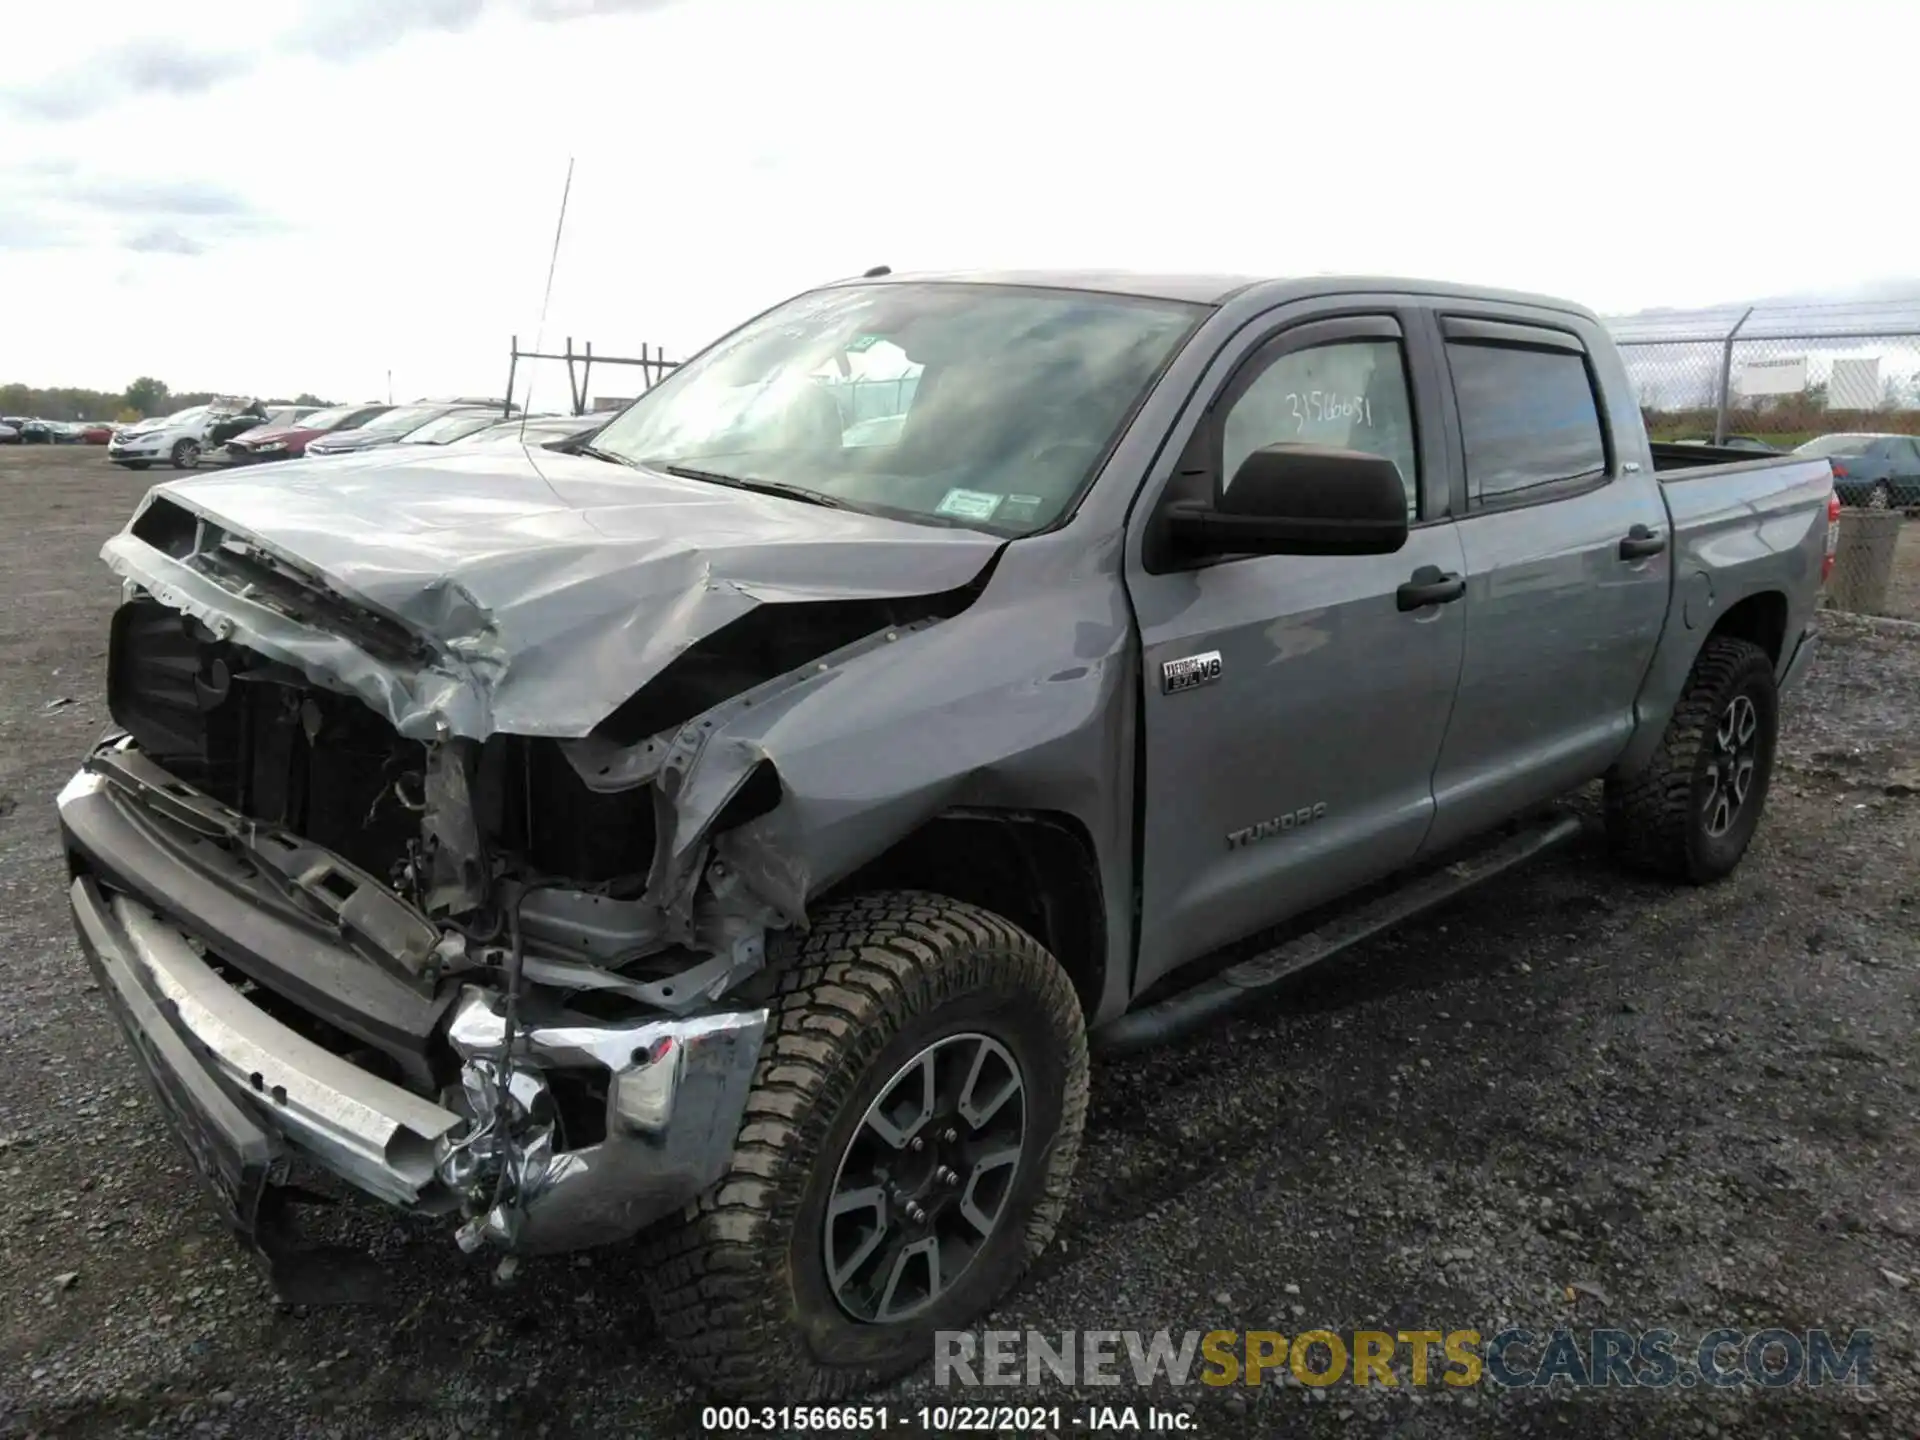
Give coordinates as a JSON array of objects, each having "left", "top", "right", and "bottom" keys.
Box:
[{"left": 60, "top": 275, "right": 1836, "bottom": 1400}]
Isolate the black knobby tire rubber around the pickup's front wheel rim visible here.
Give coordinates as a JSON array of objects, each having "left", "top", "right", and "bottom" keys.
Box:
[{"left": 643, "top": 891, "right": 1087, "bottom": 1402}]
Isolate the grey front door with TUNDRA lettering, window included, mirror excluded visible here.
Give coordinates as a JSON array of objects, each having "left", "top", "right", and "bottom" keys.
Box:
[{"left": 1127, "top": 305, "right": 1463, "bottom": 987}]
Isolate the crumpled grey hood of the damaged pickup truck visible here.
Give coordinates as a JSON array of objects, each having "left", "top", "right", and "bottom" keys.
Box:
[{"left": 102, "top": 447, "right": 1002, "bottom": 739}]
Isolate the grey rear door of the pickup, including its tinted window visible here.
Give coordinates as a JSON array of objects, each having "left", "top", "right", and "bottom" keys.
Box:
[{"left": 1427, "top": 309, "right": 1672, "bottom": 851}]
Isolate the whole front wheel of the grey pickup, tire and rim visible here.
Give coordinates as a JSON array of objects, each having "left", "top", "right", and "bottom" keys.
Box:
[{"left": 649, "top": 893, "right": 1087, "bottom": 1400}]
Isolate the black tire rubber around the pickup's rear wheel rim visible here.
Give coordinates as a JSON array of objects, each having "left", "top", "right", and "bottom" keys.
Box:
[{"left": 1605, "top": 636, "right": 1780, "bottom": 885}]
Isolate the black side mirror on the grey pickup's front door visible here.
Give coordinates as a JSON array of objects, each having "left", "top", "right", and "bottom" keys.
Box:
[{"left": 1167, "top": 445, "right": 1407, "bottom": 555}]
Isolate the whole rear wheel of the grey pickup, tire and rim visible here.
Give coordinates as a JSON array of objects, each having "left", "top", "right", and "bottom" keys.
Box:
[{"left": 1607, "top": 636, "right": 1780, "bottom": 883}]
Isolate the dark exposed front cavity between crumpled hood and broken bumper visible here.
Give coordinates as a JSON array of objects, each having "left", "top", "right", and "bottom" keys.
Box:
[{"left": 109, "top": 599, "right": 778, "bottom": 990}]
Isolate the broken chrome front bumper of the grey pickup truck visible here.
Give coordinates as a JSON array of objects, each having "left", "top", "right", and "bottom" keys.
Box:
[{"left": 60, "top": 747, "right": 766, "bottom": 1282}]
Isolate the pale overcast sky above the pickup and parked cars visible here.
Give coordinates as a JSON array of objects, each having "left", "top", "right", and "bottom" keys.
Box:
[{"left": 0, "top": 0, "right": 1920, "bottom": 405}]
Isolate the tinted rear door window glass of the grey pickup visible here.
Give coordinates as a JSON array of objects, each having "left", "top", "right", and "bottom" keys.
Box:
[{"left": 1446, "top": 338, "right": 1607, "bottom": 505}]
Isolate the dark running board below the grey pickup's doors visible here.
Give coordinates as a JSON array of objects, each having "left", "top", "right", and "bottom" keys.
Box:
[{"left": 1089, "top": 814, "right": 1584, "bottom": 1054}]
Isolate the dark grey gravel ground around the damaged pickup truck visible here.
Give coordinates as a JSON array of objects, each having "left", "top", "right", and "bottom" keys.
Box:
[{"left": 0, "top": 451, "right": 1920, "bottom": 1440}]
